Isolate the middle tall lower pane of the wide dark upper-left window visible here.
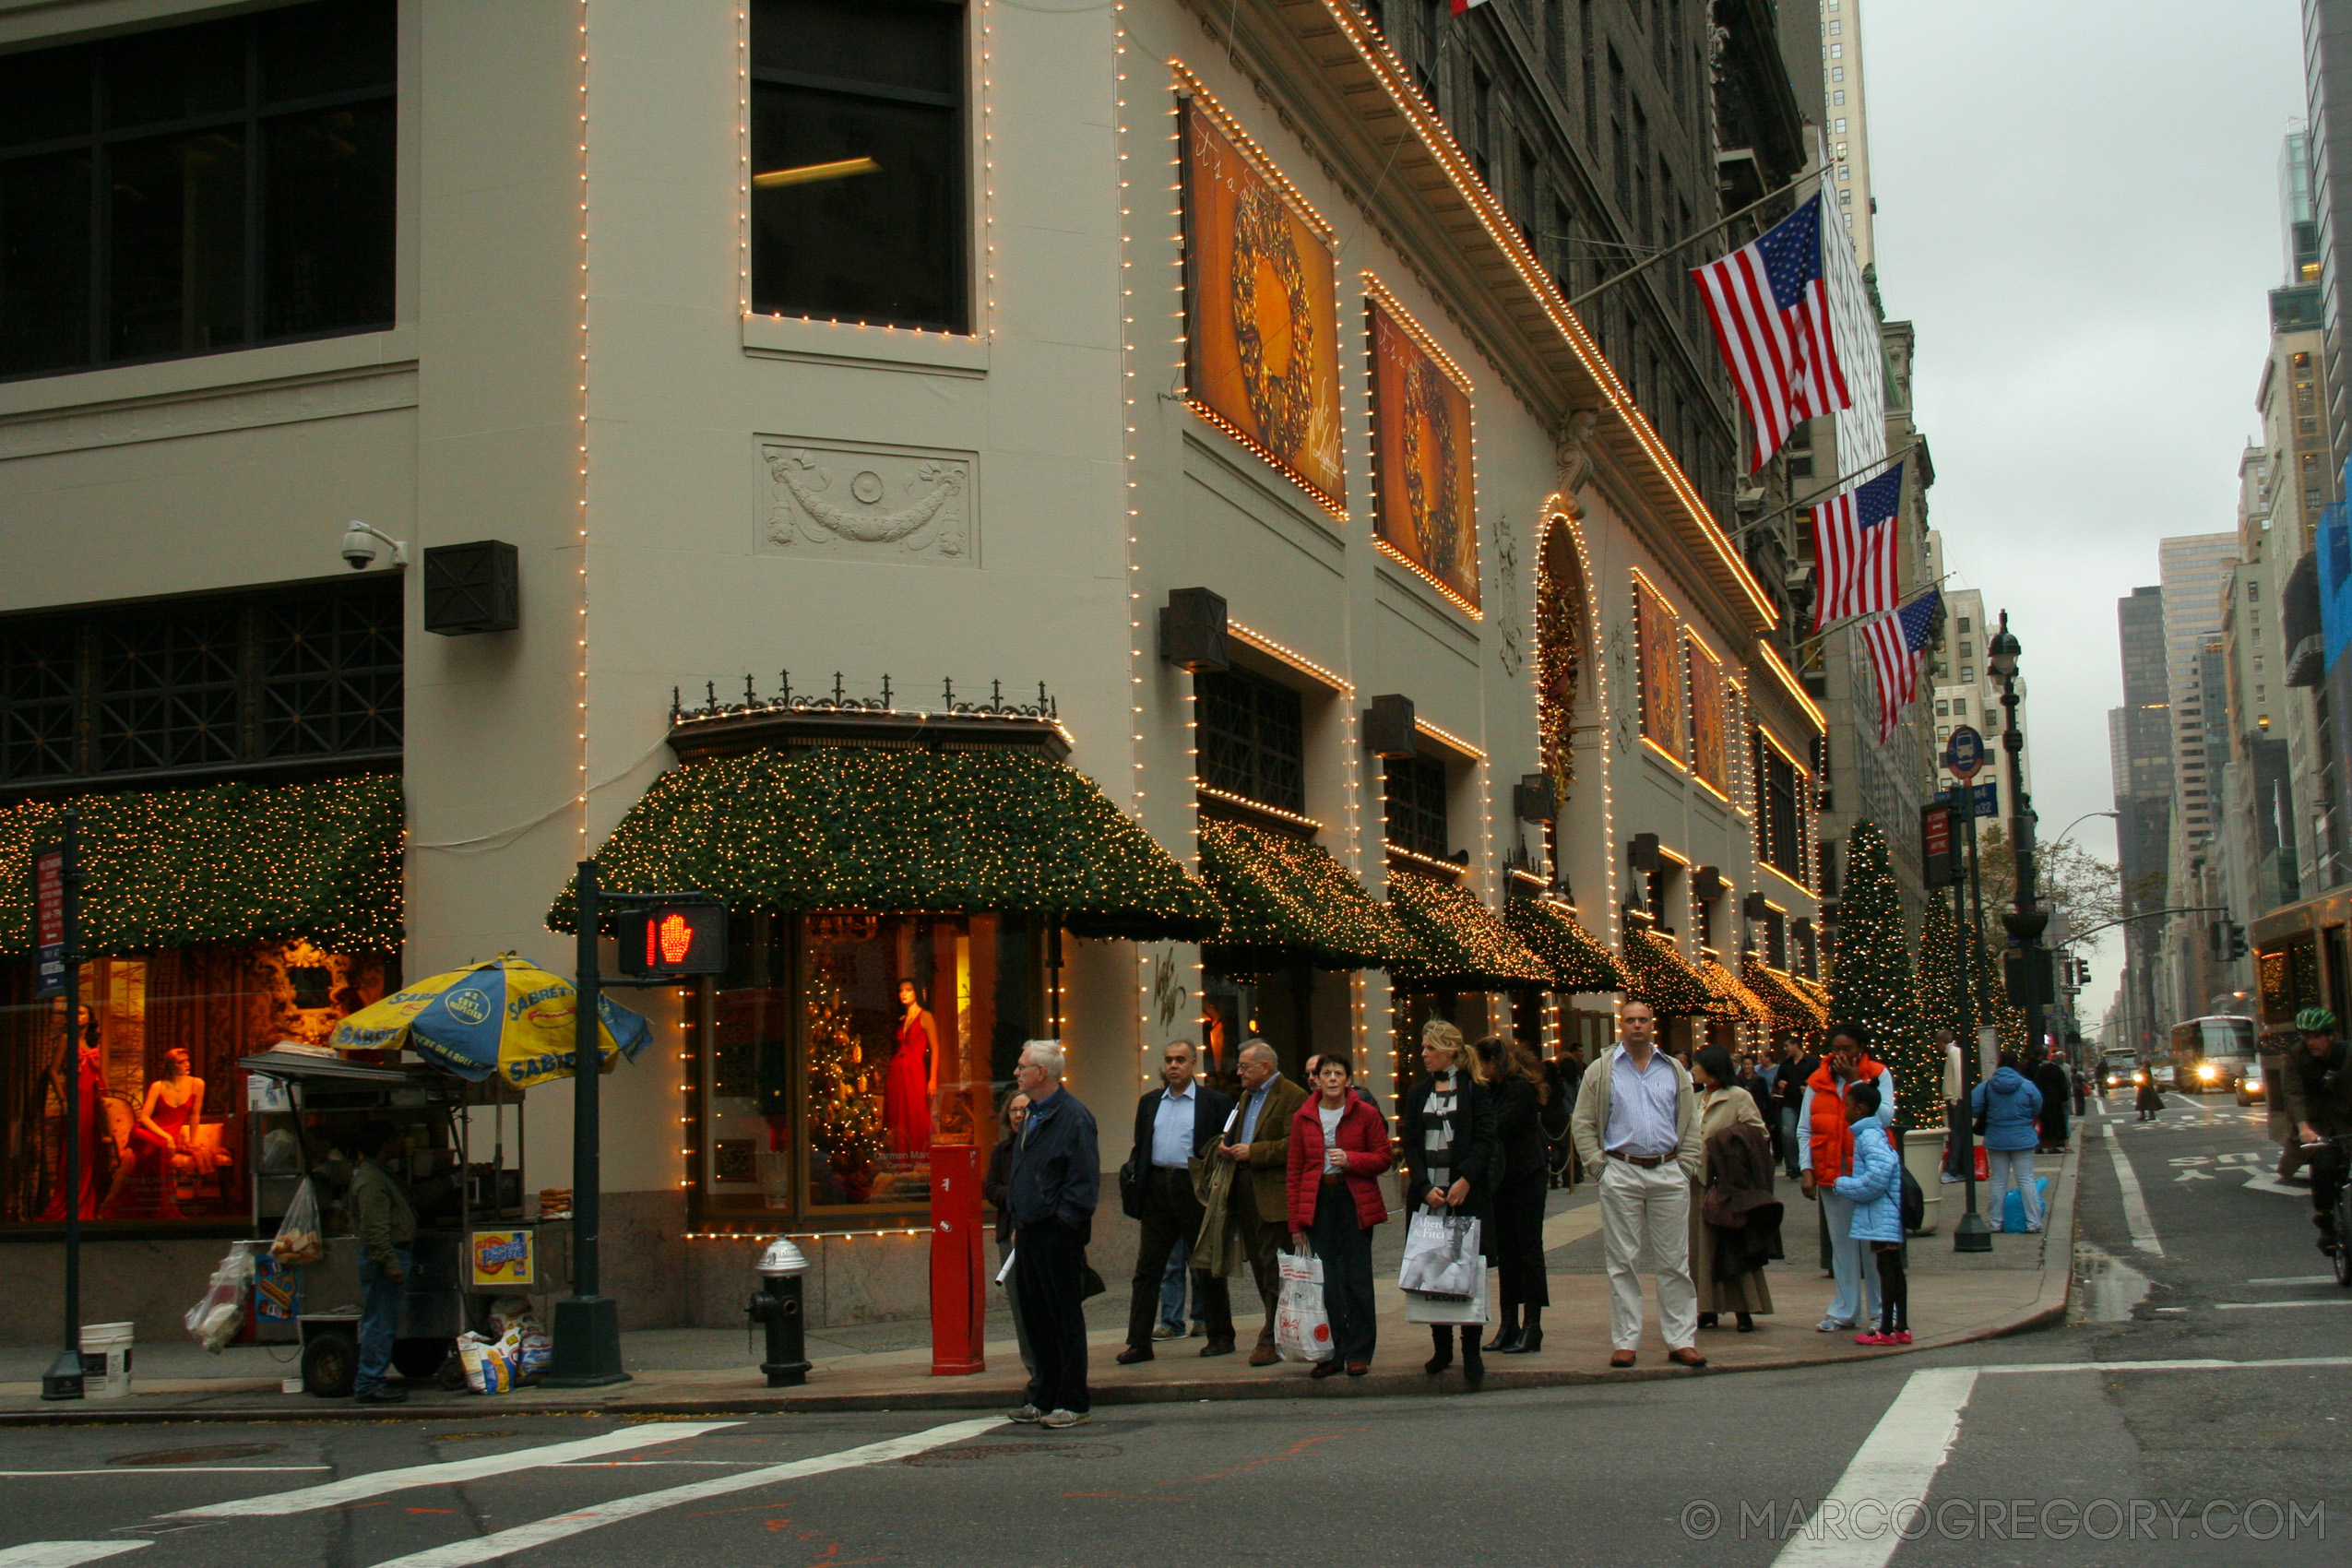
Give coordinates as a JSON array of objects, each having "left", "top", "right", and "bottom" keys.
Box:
[{"left": 111, "top": 127, "right": 244, "bottom": 360}]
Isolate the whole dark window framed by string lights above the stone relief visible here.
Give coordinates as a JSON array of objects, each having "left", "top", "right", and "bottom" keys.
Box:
[{"left": 750, "top": 0, "right": 971, "bottom": 331}]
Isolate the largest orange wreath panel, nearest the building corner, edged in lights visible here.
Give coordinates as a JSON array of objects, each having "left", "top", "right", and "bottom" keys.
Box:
[{"left": 1179, "top": 91, "right": 1348, "bottom": 515}]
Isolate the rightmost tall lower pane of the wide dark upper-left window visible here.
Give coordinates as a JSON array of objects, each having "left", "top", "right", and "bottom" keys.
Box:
[{"left": 261, "top": 99, "right": 393, "bottom": 339}]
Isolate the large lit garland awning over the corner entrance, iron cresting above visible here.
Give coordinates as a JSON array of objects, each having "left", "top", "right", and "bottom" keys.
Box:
[{"left": 548, "top": 745, "right": 1223, "bottom": 940}]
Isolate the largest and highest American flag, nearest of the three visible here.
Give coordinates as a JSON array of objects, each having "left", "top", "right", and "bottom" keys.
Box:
[{"left": 1691, "top": 196, "right": 1848, "bottom": 472}]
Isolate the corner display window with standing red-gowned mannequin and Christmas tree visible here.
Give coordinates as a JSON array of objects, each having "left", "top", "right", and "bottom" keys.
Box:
[{"left": 687, "top": 914, "right": 1049, "bottom": 1229}]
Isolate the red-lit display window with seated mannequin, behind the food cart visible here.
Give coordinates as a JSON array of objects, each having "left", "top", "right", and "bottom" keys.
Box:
[{"left": 0, "top": 940, "right": 400, "bottom": 1225}]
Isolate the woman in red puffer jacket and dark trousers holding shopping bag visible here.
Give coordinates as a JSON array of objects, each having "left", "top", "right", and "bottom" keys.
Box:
[{"left": 1289, "top": 1055, "right": 1395, "bottom": 1378}]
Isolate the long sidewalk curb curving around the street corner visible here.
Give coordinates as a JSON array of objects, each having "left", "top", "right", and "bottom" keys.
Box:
[{"left": 0, "top": 1126, "right": 2084, "bottom": 1427}]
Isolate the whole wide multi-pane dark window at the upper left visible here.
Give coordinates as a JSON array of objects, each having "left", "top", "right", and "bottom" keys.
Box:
[{"left": 0, "top": 0, "right": 398, "bottom": 376}]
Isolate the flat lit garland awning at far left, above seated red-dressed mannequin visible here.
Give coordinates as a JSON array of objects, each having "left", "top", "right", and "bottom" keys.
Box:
[{"left": 0, "top": 774, "right": 405, "bottom": 956}]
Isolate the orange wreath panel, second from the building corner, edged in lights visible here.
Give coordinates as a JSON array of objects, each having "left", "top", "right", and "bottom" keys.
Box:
[{"left": 1367, "top": 288, "right": 1479, "bottom": 616}]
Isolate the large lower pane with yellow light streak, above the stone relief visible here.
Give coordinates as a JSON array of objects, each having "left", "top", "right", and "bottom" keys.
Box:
[{"left": 753, "top": 85, "right": 967, "bottom": 331}]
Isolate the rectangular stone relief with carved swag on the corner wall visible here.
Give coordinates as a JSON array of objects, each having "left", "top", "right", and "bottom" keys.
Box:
[{"left": 760, "top": 440, "right": 980, "bottom": 566}]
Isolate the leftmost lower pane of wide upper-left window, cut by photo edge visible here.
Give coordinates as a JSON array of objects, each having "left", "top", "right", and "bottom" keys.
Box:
[{"left": 0, "top": 153, "right": 89, "bottom": 376}]
